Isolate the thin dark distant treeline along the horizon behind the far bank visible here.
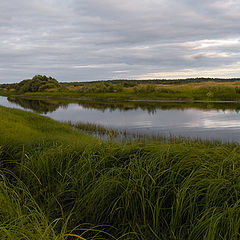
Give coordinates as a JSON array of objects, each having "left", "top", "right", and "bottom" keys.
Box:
[{"left": 0, "top": 78, "right": 240, "bottom": 88}]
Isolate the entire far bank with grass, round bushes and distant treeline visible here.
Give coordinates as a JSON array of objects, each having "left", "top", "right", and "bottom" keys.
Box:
[{"left": 0, "top": 75, "right": 240, "bottom": 101}]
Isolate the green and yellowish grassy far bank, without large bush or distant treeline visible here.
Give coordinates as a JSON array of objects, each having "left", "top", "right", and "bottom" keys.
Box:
[{"left": 0, "top": 82, "right": 240, "bottom": 101}]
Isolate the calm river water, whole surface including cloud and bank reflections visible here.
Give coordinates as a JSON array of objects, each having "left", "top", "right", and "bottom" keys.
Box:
[{"left": 0, "top": 97, "right": 240, "bottom": 142}]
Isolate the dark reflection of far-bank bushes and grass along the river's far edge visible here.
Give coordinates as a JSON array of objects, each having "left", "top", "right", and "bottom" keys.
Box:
[{"left": 3, "top": 97, "right": 240, "bottom": 114}]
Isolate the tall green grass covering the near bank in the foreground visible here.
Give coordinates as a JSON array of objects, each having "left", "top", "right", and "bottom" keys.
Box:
[{"left": 0, "top": 107, "right": 240, "bottom": 240}]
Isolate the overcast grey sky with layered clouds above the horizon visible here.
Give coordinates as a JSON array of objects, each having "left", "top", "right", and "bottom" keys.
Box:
[{"left": 0, "top": 0, "right": 240, "bottom": 83}]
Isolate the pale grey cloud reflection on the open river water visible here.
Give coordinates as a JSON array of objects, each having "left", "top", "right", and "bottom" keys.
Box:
[{"left": 47, "top": 104, "right": 238, "bottom": 130}]
